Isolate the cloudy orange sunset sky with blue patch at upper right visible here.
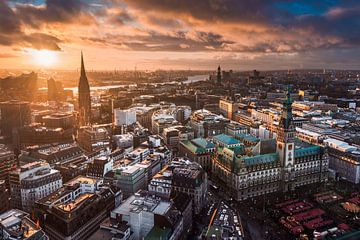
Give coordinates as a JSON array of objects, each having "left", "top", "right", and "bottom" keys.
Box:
[{"left": 0, "top": 0, "right": 360, "bottom": 70}]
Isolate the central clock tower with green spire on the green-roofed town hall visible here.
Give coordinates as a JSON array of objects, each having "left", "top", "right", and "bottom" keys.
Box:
[{"left": 276, "top": 87, "right": 296, "bottom": 192}]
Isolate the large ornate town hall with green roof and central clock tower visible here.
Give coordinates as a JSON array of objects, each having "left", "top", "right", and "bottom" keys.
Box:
[{"left": 213, "top": 88, "right": 328, "bottom": 200}]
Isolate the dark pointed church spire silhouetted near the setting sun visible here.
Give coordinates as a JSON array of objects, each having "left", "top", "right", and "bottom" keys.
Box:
[{"left": 78, "top": 52, "right": 91, "bottom": 126}]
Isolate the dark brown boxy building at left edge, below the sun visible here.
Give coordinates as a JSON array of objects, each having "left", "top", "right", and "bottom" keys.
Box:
[{"left": 0, "top": 101, "right": 31, "bottom": 143}]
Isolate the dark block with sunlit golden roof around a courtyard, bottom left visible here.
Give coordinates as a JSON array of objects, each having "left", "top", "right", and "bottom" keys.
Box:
[{"left": 35, "top": 176, "right": 121, "bottom": 240}]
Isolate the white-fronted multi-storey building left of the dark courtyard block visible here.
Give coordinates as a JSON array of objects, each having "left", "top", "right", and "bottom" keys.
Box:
[{"left": 9, "top": 162, "right": 62, "bottom": 212}]
